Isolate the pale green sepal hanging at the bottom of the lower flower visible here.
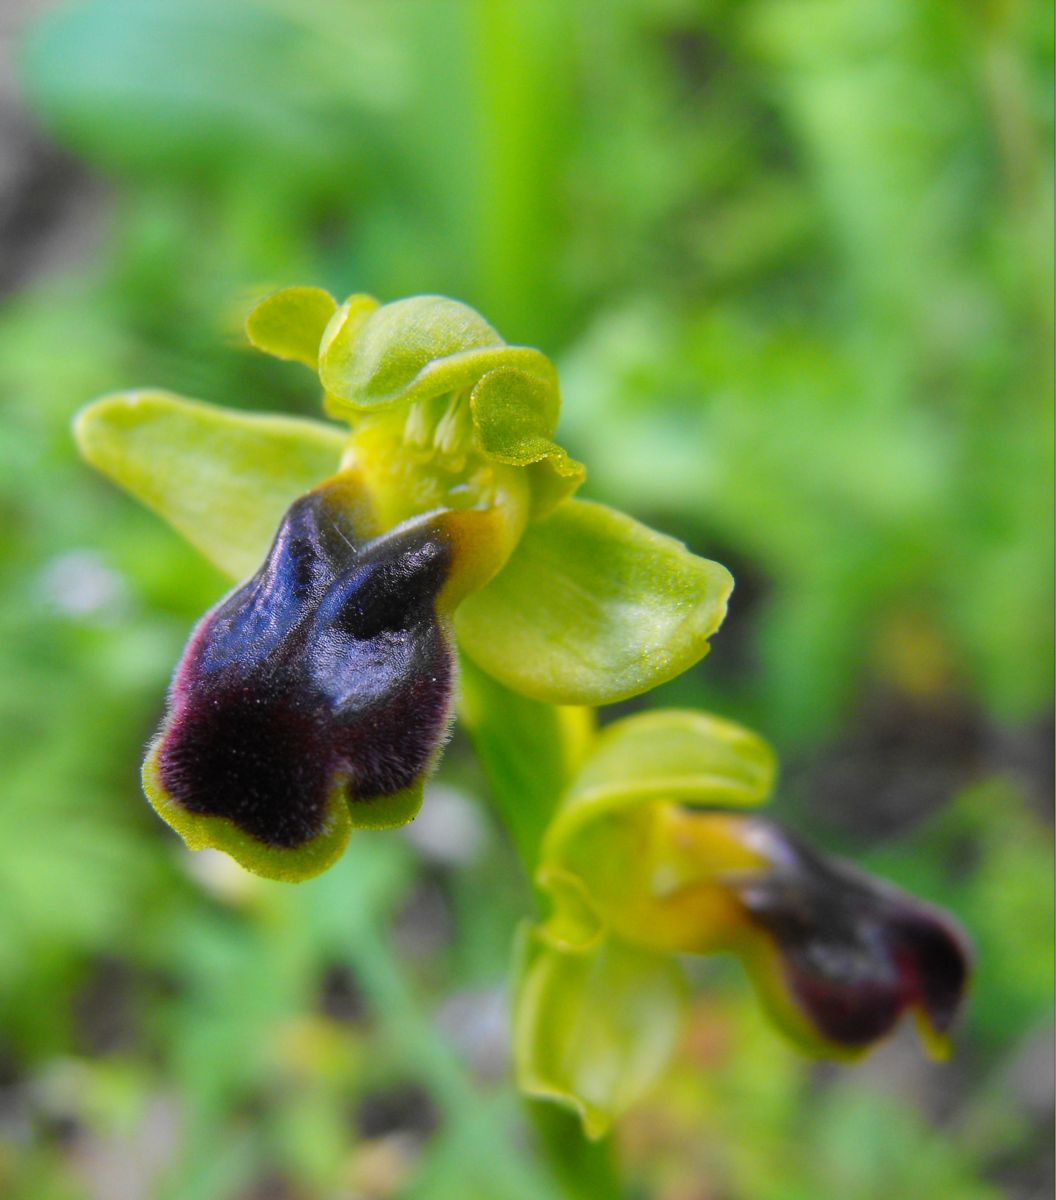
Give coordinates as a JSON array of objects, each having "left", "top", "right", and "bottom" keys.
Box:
[{"left": 514, "top": 940, "right": 685, "bottom": 1138}]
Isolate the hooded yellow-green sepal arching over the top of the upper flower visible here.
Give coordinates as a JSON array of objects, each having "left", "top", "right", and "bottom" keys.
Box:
[{"left": 319, "top": 295, "right": 557, "bottom": 412}]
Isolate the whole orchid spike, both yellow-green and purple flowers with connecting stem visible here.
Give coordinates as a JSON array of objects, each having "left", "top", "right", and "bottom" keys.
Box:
[{"left": 76, "top": 288, "right": 970, "bottom": 1142}]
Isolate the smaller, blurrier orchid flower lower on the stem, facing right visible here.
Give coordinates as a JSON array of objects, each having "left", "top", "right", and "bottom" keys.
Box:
[{"left": 514, "top": 709, "right": 968, "bottom": 1136}]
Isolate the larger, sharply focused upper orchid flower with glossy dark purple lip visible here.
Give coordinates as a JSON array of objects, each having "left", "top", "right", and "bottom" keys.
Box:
[{"left": 74, "top": 288, "right": 732, "bottom": 881}]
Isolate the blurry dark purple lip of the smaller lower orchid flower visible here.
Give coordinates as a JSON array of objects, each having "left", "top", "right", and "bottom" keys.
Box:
[{"left": 734, "top": 821, "right": 968, "bottom": 1048}]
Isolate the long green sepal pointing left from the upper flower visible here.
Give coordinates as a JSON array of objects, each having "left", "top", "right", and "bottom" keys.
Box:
[{"left": 73, "top": 391, "right": 346, "bottom": 578}]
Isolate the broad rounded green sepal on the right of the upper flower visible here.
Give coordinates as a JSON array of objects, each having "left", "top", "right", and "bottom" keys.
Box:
[{"left": 456, "top": 500, "right": 733, "bottom": 704}]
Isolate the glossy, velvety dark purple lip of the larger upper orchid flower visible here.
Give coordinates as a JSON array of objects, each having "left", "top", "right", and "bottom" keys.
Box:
[{"left": 156, "top": 480, "right": 454, "bottom": 848}]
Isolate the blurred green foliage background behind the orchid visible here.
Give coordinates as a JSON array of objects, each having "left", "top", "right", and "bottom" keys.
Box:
[{"left": 0, "top": 0, "right": 1052, "bottom": 1200}]
